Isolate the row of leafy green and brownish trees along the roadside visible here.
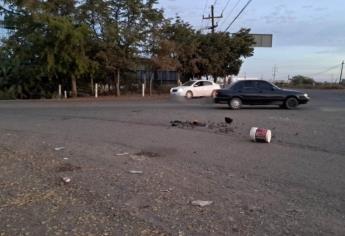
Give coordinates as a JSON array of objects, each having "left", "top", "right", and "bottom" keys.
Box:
[{"left": 0, "top": 0, "right": 254, "bottom": 98}]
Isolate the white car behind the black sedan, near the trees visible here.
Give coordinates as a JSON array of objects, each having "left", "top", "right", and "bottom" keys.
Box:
[{"left": 170, "top": 80, "right": 220, "bottom": 98}]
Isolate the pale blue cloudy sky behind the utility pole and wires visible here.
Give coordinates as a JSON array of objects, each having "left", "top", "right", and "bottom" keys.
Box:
[{"left": 158, "top": 0, "right": 345, "bottom": 82}]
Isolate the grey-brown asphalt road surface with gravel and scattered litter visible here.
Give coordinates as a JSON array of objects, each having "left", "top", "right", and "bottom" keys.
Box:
[{"left": 0, "top": 90, "right": 345, "bottom": 236}]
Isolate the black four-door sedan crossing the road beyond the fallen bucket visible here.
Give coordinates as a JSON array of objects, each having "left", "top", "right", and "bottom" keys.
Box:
[{"left": 214, "top": 80, "right": 310, "bottom": 109}]
